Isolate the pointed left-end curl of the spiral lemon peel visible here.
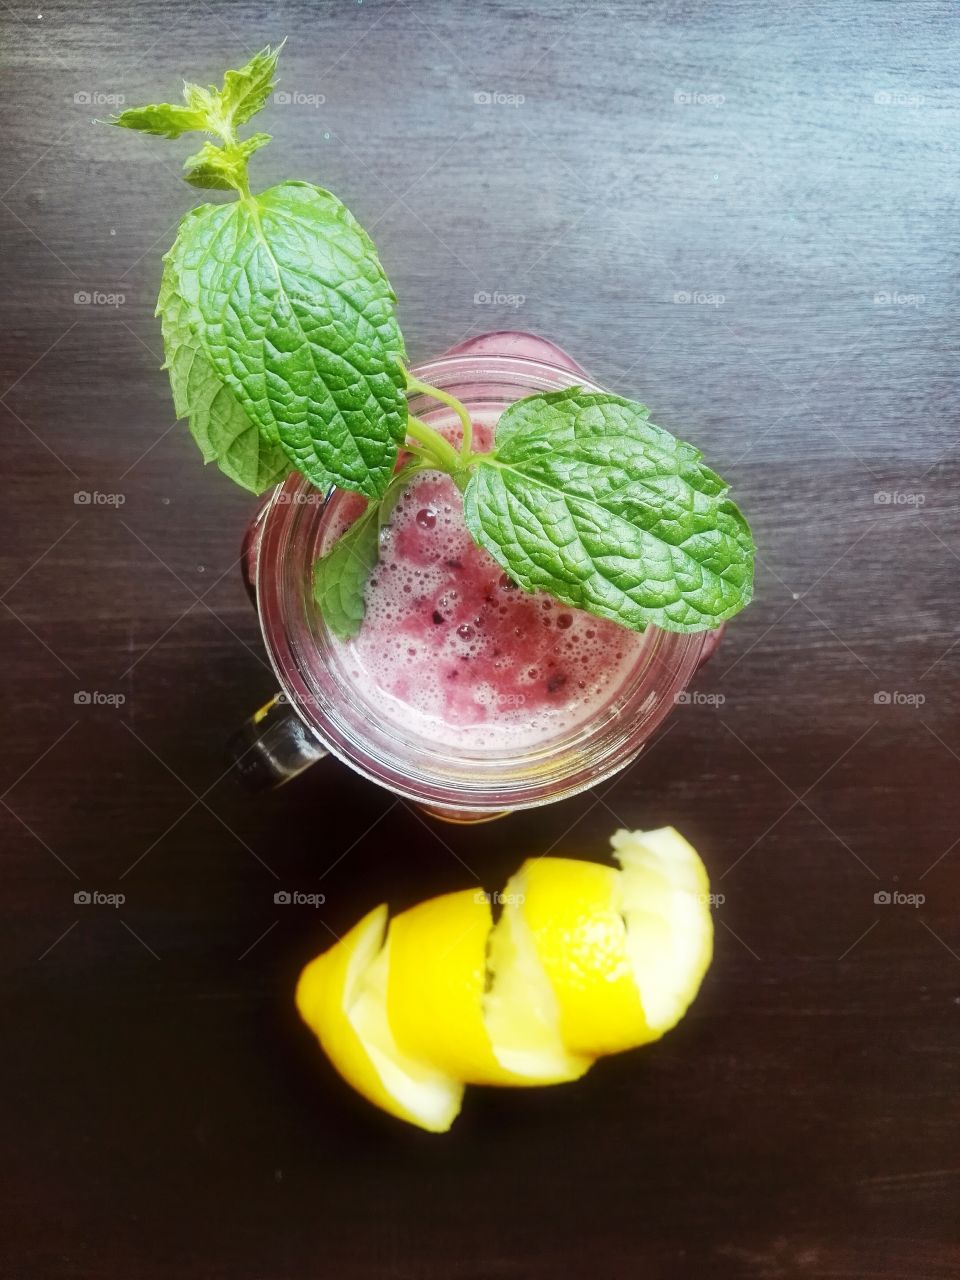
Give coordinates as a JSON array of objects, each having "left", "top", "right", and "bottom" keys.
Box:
[{"left": 296, "top": 905, "right": 463, "bottom": 1133}]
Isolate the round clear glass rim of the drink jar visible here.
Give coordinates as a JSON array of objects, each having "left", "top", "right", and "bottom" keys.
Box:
[{"left": 256, "top": 355, "right": 705, "bottom": 813}]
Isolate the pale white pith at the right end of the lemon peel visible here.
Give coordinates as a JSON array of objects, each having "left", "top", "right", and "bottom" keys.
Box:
[{"left": 611, "top": 827, "right": 713, "bottom": 1038}]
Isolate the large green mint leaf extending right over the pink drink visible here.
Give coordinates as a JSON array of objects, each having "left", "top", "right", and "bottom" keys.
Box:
[{"left": 463, "top": 388, "right": 754, "bottom": 631}]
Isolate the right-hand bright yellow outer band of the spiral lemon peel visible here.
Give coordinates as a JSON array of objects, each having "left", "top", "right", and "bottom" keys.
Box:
[{"left": 515, "top": 858, "right": 655, "bottom": 1056}]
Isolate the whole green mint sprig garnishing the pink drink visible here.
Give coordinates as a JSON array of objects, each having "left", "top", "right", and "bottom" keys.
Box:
[{"left": 110, "top": 45, "right": 754, "bottom": 639}]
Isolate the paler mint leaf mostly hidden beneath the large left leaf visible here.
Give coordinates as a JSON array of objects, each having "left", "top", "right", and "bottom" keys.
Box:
[{"left": 157, "top": 244, "right": 291, "bottom": 494}]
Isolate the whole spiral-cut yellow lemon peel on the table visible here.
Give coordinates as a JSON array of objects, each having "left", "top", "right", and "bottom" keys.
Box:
[{"left": 296, "top": 827, "right": 713, "bottom": 1133}]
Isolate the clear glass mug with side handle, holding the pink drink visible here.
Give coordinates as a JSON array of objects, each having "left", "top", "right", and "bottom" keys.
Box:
[{"left": 230, "top": 333, "right": 722, "bottom": 822}]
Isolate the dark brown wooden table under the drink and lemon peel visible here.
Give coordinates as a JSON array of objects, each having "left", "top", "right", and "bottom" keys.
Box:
[{"left": 0, "top": 0, "right": 960, "bottom": 1280}]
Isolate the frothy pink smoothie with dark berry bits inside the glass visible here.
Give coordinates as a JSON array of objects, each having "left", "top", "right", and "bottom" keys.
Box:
[{"left": 321, "top": 427, "right": 650, "bottom": 751}]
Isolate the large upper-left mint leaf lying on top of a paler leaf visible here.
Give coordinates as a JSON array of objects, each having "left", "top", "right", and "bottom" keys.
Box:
[{"left": 173, "top": 182, "right": 407, "bottom": 498}]
